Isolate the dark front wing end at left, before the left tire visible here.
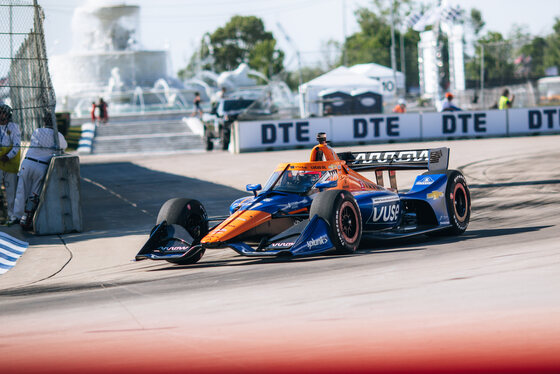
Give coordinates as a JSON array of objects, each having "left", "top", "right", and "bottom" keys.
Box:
[{"left": 135, "top": 221, "right": 202, "bottom": 261}]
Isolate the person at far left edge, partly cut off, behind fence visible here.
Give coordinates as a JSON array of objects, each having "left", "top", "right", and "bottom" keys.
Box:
[{"left": 0, "top": 104, "right": 21, "bottom": 225}]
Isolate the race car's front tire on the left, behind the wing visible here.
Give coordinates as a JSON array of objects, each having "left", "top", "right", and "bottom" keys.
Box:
[{"left": 156, "top": 198, "right": 208, "bottom": 265}]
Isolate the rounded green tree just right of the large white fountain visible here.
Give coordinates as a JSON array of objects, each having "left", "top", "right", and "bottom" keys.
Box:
[{"left": 183, "top": 16, "right": 284, "bottom": 77}]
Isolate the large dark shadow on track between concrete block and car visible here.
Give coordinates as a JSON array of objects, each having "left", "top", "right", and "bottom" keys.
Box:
[{"left": 23, "top": 162, "right": 248, "bottom": 245}]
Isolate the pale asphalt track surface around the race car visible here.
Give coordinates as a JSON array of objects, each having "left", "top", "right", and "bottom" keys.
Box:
[{"left": 0, "top": 135, "right": 560, "bottom": 373}]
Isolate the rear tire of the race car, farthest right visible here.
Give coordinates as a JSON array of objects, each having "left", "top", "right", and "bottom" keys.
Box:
[{"left": 445, "top": 170, "right": 471, "bottom": 235}]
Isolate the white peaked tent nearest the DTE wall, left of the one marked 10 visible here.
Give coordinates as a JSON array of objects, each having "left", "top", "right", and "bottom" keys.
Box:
[{"left": 299, "top": 66, "right": 382, "bottom": 117}]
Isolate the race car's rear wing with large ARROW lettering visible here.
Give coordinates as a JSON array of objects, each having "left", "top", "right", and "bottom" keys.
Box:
[{"left": 338, "top": 147, "right": 449, "bottom": 190}]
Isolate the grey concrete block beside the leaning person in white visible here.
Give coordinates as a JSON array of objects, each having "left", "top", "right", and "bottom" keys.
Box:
[{"left": 33, "top": 155, "right": 82, "bottom": 235}]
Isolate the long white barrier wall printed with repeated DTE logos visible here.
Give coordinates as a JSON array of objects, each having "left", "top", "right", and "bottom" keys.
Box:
[{"left": 233, "top": 107, "right": 560, "bottom": 153}]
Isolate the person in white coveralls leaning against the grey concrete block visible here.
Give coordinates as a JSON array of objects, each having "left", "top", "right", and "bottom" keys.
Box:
[{"left": 14, "top": 115, "right": 68, "bottom": 225}]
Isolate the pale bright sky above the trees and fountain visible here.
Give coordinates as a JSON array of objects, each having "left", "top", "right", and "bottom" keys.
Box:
[{"left": 38, "top": 0, "right": 560, "bottom": 72}]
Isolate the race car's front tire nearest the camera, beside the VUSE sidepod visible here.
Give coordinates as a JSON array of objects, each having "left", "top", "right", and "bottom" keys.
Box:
[{"left": 309, "top": 190, "right": 362, "bottom": 253}]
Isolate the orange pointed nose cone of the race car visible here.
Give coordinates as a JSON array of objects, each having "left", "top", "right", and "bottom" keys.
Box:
[{"left": 200, "top": 210, "right": 271, "bottom": 244}]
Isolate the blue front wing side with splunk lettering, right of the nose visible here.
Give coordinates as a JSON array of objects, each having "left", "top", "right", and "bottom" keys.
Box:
[{"left": 228, "top": 216, "right": 334, "bottom": 256}]
